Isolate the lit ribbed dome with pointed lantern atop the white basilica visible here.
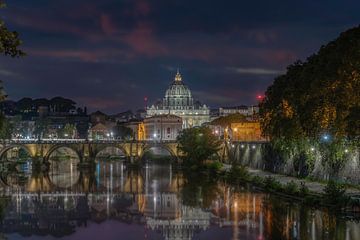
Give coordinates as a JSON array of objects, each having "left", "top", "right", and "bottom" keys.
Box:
[{"left": 163, "top": 71, "right": 194, "bottom": 109}]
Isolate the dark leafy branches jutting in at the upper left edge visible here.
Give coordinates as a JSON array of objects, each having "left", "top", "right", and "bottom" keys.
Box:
[{"left": 0, "top": 1, "right": 25, "bottom": 57}]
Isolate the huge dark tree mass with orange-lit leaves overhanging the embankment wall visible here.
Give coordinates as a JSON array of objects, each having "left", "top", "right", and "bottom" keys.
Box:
[{"left": 260, "top": 27, "right": 360, "bottom": 180}]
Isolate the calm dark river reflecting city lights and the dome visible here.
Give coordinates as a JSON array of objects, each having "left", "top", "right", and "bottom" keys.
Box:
[{"left": 0, "top": 159, "right": 360, "bottom": 240}]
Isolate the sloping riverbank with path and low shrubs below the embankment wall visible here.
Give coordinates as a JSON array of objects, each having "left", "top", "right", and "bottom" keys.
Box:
[{"left": 222, "top": 164, "right": 360, "bottom": 211}]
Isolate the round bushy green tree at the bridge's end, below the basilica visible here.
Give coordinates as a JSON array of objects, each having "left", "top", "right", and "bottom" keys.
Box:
[{"left": 177, "top": 127, "right": 221, "bottom": 165}]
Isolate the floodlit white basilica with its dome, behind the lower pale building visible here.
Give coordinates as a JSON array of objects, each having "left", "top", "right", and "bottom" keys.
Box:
[{"left": 147, "top": 71, "right": 210, "bottom": 128}]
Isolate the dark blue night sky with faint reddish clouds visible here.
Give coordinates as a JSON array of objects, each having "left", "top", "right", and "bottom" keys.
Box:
[{"left": 0, "top": 0, "right": 360, "bottom": 113}]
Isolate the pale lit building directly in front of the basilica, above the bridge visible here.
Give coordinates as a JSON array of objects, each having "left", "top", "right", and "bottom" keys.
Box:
[{"left": 144, "top": 115, "right": 183, "bottom": 141}]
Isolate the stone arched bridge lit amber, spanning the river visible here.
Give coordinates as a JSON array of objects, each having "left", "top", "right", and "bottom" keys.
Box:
[{"left": 0, "top": 139, "right": 263, "bottom": 164}]
